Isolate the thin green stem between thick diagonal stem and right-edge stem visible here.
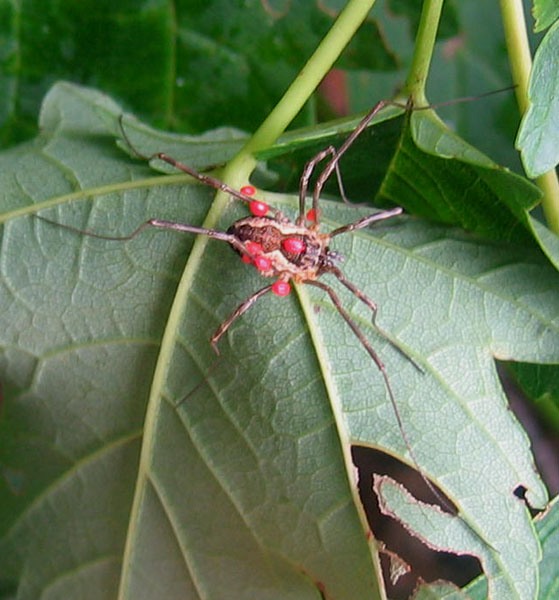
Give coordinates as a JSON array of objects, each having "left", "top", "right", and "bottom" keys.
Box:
[{"left": 404, "top": 0, "right": 444, "bottom": 106}]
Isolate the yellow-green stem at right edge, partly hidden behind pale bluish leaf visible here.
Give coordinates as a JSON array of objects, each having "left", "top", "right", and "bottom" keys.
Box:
[{"left": 501, "top": 0, "right": 559, "bottom": 233}]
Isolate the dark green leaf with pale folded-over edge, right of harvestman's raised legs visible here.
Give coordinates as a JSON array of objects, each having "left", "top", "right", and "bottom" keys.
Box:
[{"left": 390, "top": 111, "right": 540, "bottom": 241}]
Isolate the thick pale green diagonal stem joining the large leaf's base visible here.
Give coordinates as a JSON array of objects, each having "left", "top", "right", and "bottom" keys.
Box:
[{"left": 223, "top": 0, "right": 375, "bottom": 183}]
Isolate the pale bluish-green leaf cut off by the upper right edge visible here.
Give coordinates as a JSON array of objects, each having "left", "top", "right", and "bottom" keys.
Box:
[{"left": 516, "top": 21, "right": 559, "bottom": 178}]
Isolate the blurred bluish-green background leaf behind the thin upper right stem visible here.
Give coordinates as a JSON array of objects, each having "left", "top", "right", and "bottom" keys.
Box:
[{"left": 349, "top": 0, "right": 521, "bottom": 171}]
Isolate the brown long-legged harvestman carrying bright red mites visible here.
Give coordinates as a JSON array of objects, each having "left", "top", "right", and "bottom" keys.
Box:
[{"left": 38, "top": 101, "right": 447, "bottom": 504}]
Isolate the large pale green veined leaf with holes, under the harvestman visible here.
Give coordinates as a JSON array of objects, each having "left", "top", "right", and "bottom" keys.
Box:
[{"left": 0, "top": 85, "right": 559, "bottom": 600}]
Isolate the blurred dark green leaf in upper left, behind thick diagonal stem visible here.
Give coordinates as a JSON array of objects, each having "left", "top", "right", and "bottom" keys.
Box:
[{"left": 0, "top": 0, "right": 396, "bottom": 142}]
